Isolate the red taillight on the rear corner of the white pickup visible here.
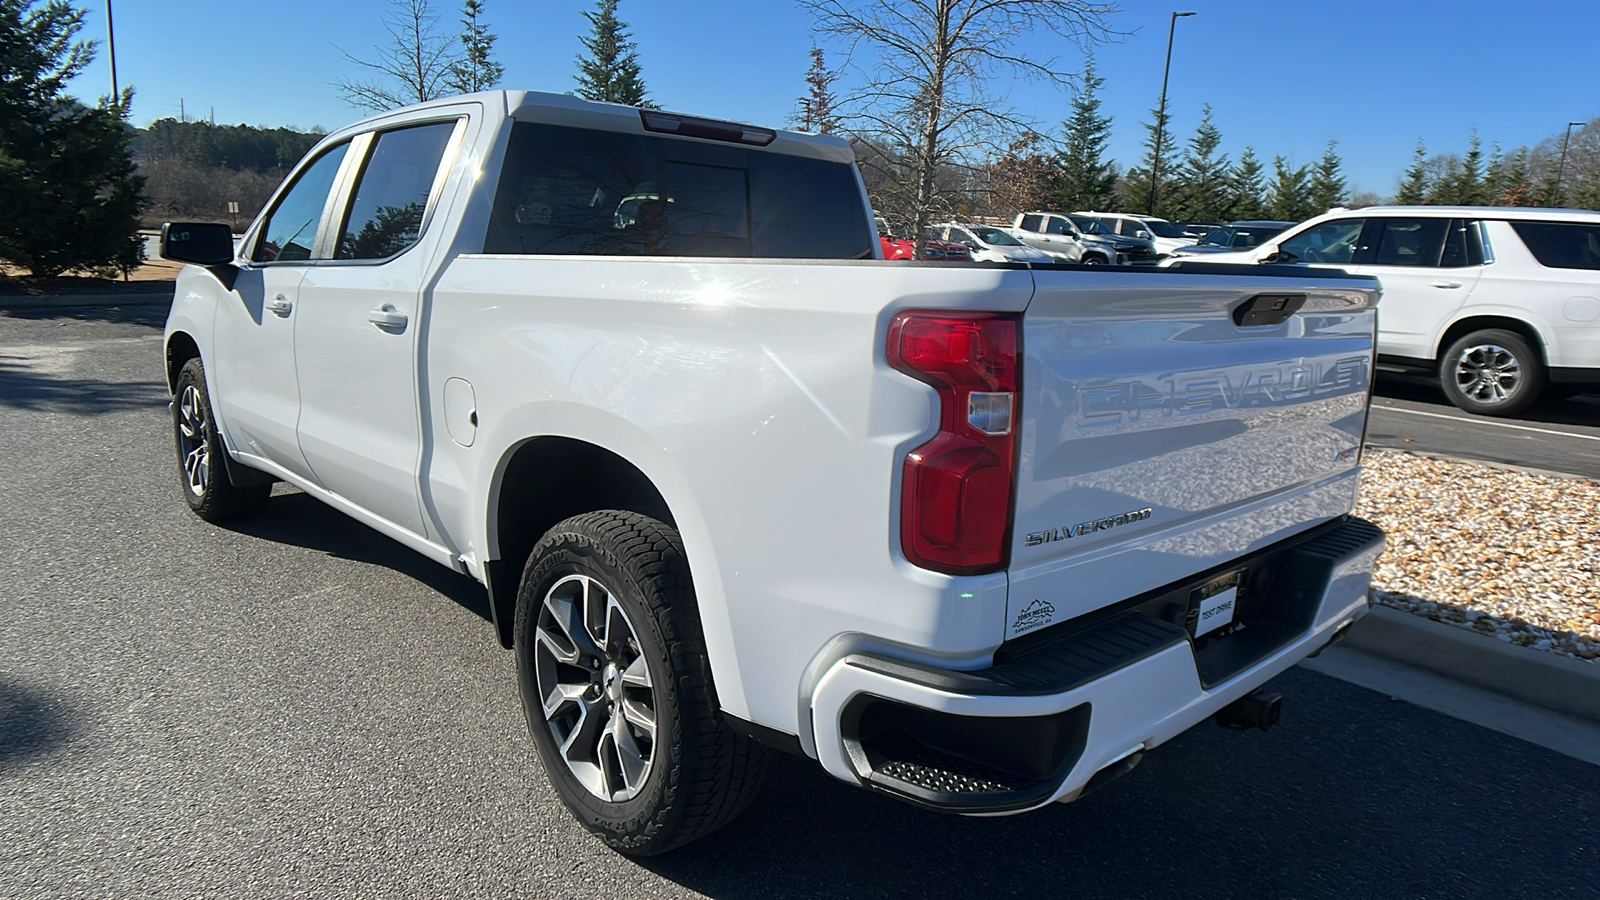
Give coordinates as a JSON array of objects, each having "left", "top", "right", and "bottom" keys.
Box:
[{"left": 888, "top": 312, "right": 1019, "bottom": 575}]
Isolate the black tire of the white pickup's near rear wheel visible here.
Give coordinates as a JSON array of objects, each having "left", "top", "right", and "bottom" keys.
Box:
[{"left": 514, "top": 509, "right": 766, "bottom": 857}]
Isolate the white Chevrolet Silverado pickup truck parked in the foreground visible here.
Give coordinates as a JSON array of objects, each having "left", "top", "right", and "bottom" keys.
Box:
[{"left": 162, "top": 91, "right": 1384, "bottom": 854}]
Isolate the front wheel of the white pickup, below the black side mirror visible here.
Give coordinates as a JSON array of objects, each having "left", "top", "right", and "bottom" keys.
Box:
[{"left": 173, "top": 357, "right": 272, "bottom": 522}]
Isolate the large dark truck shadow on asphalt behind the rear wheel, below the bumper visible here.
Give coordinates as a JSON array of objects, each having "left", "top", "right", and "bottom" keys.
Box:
[{"left": 643, "top": 669, "right": 1600, "bottom": 900}]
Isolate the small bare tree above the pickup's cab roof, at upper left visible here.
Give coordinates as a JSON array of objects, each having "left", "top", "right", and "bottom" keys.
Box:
[{"left": 334, "top": 0, "right": 459, "bottom": 112}]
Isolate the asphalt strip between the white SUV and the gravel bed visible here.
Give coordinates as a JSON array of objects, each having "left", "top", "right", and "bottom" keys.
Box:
[{"left": 1366, "top": 373, "right": 1600, "bottom": 479}]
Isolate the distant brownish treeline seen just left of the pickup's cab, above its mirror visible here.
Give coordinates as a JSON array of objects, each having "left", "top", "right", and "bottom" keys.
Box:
[{"left": 133, "top": 119, "right": 323, "bottom": 227}]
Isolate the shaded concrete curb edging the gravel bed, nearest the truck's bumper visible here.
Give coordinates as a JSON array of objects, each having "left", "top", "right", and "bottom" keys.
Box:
[{"left": 1344, "top": 605, "right": 1600, "bottom": 724}]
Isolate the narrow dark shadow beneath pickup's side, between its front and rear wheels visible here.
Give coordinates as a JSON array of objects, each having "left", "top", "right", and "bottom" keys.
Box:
[{"left": 221, "top": 485, "right": 490, "bottom": 621}]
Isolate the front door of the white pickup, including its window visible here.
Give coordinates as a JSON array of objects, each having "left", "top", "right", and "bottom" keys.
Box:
[{"left": 205, "top": 143, "right": 350, "bottom": 480}]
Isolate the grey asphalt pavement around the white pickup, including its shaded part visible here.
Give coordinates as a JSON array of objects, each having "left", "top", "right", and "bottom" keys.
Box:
[{"left": 9, "top": 307, "right": 1600, "bottom": 900}]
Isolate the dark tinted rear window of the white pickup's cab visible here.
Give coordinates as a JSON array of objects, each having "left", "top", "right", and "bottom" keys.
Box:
[{"left": 483, "top": 122, "right": 872, "bottom": 259}]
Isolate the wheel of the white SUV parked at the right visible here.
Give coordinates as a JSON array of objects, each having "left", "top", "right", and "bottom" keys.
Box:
[{"left": 1438, "top": 328, "right": 1549, "bottom": 416}]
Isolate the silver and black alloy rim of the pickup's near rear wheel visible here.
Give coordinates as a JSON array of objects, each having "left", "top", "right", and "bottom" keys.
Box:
[{"left": 533, "top": 575, "right": 656, "bottom": 802}]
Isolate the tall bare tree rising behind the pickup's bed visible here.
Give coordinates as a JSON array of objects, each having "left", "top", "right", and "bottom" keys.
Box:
[{"left": 800, "top": 0, "right": 1117, "bottom": 253}]
